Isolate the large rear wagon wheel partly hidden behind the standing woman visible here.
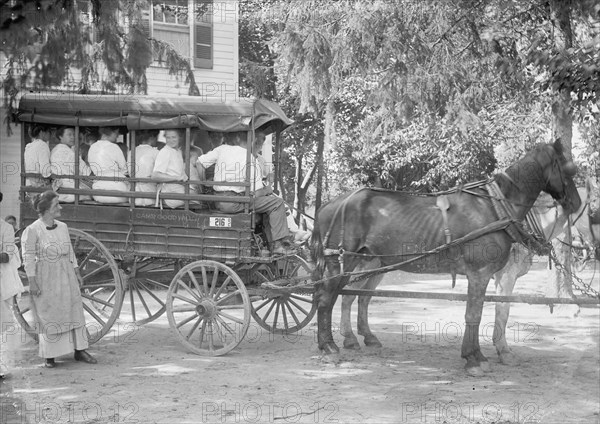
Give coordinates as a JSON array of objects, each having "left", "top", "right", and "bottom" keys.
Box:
[{"left": 13, "top": 228, "right": 123, "bottom": 344}]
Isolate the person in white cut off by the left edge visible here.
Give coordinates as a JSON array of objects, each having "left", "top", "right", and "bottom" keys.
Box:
[{"left": 0, "top": 192, "right": 23, "bottom": 378}]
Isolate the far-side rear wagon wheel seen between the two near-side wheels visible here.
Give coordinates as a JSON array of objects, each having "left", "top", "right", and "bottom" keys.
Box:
[{"left": 119, "top": 256, "right": 180, "bottom": 325}]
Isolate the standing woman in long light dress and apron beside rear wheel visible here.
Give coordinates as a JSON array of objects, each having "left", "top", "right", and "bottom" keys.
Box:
[{"left": 21, "top": 190, "right": 96, "bottom": 368}]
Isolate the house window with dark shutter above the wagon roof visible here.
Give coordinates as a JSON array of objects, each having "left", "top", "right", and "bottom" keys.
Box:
[{"left": 142, "top": 0, "right": 214, "bottom": 69}]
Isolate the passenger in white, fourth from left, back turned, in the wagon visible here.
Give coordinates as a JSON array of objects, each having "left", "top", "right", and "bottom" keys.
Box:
[{"left": 128, "top": 130, "right": 159, "bottom": 206}]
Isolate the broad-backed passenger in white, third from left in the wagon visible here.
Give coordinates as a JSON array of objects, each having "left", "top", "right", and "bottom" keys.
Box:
[{"left": 88, "top": 127, "right": 129, "bottom": 203}]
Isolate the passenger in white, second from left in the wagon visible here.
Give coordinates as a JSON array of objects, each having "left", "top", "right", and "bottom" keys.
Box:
[{"left": 50, "top": 127, "right": 91, "bottom": 203}]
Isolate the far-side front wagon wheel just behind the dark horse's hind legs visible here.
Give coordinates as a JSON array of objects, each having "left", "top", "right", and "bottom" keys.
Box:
[{"left": 251, "top": 256, "right": 317, "bottom": 334}]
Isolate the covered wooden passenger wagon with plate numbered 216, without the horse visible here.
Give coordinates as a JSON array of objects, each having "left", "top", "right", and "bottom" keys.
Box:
[{"left": 13, "top": 93, "right": 316, "bottom": 356}]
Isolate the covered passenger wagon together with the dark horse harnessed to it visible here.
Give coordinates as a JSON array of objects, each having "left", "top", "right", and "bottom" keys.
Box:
[{"left": 14, "top": 94, "right": 597, "bottom": 372}]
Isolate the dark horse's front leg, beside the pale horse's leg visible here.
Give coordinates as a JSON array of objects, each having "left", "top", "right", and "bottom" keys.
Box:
[{"left": 461, "top": 272, "right": 491, "bottom": 376}]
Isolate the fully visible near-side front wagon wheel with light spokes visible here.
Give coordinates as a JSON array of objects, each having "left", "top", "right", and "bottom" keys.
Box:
[{"left": 167, "top": 261, "right": 250, "bottom": 356}]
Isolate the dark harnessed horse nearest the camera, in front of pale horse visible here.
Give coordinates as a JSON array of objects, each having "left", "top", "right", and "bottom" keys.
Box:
[{"left": 311, "top": 140, "right": 581, "bottom": 376}]
